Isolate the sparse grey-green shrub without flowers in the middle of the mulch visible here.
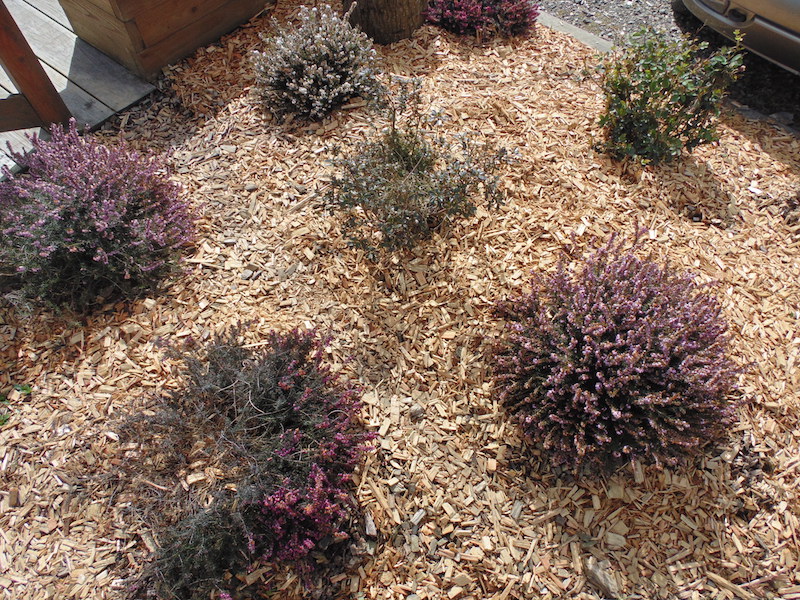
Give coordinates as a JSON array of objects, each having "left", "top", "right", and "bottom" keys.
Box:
[{"left": 325, "top": 81, "right": 505, "bottom": 255}]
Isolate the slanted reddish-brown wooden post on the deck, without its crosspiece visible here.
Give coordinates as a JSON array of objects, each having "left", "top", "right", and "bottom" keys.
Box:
[{"left": 0, "top": 1, "right": 70, "bottom": 129}]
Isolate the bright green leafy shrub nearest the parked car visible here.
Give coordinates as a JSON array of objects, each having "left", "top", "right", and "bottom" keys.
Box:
[{"left": 600, "top": 29, "right": 743, "bottom": 163}]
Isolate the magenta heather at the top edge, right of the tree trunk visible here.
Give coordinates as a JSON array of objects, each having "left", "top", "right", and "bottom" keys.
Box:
[{"left": 426, "top": 0, "right": 539, "bottom": 38}]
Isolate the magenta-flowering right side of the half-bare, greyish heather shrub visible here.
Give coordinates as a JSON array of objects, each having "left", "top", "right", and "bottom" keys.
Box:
[{"left": 239, "top": 331, "right": 374, "bottom": 570}]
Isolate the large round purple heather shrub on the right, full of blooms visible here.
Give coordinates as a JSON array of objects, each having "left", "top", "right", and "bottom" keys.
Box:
[{"left": 494, "top": 238, "right": 739, "bottom": 470}]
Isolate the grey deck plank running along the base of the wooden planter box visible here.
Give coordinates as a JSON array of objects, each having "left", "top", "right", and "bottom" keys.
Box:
[{"left": 7, "top": 0, "right": 154, "bottom": 110}]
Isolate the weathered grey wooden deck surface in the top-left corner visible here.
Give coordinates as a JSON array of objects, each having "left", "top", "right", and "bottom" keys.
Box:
[{"left": 0, "top": 0, "right": 155, "bottom": 166}]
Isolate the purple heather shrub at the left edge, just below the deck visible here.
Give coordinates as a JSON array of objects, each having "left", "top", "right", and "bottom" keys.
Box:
[{"left": 0, "top": 119, "right": 193, "bottom": 308}]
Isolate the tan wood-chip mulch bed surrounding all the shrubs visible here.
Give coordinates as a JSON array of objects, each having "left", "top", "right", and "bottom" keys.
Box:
[{"left": 0, "top": 3, "right": 800, "bottom": 600}]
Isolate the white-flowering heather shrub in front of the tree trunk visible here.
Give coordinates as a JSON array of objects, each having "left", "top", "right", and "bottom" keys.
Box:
[{"left": 253, "top": 5, "right": 382, "bottom": 121}]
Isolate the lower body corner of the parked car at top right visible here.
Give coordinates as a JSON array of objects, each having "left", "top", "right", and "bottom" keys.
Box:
[{"left": 672, "top": 0, "right": 800, "bottom": 75}]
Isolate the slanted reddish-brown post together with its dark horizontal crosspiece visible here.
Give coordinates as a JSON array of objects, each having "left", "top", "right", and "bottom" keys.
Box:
[{"left": 0, "top": 0, "right": 71, "bottom": 131}]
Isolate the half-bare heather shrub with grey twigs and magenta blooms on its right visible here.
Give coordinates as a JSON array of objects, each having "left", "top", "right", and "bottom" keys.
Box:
[{"left": 124, "top": 331, "right": 373, "bottom": 600}]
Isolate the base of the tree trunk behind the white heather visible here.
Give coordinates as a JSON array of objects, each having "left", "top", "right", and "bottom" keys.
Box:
[{"left": 343, "top": 0, "right": 428, "bottom": 44}]
